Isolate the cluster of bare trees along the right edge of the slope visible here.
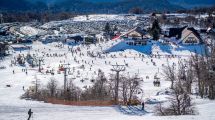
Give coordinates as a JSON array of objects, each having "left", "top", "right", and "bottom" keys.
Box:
[{"left": 157, "top": 43, "right": 215, "bottom": 115}]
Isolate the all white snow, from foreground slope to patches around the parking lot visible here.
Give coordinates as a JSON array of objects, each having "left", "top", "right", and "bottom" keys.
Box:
[{"left": 0, "top": 14, "right": 215, "bottom": 120}]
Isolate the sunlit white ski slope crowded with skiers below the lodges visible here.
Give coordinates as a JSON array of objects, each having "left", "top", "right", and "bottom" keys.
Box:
[{"left": 0, "top": 41, "right": 215, "bottom": 120}]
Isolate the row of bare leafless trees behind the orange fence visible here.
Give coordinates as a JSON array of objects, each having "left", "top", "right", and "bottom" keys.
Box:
[{"left": 21, "top": 70, "right": 142, "bottom": 104}]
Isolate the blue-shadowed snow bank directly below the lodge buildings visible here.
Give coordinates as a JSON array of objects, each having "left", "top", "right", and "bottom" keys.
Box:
[{"left": 106, "top": 41, "right": 205, "bottom": 56}]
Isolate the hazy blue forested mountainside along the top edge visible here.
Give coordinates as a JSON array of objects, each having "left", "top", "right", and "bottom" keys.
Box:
[{"left": 0, "top": 0, "right": 182, "bottom": 13}]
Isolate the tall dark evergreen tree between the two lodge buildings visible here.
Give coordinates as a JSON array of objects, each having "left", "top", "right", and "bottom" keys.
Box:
[{"left": 150, "top": 19, "right": 161, "bottom": 40}]
